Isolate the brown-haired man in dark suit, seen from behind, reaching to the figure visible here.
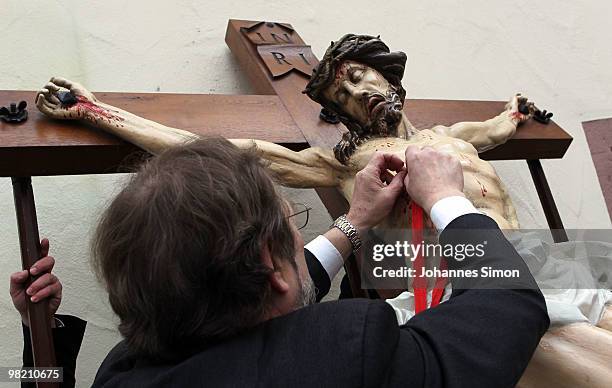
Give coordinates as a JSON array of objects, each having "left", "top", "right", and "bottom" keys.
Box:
[{"left": 11, "top": 139, "right": 548, "bottom": 387}]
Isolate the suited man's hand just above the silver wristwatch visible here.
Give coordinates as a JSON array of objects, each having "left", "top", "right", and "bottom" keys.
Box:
[{"left": 347, "top": 152, "right": 406, "bottom": 231}]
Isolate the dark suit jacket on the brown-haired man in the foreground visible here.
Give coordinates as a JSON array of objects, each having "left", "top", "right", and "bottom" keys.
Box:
[{"left": 25, "top": 215, "right": 549, "bottom": 388}]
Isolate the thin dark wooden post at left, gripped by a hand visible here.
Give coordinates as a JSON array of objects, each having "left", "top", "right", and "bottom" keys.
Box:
[{"left": 12, "top": 177, "right": 59, "bottom": 388}]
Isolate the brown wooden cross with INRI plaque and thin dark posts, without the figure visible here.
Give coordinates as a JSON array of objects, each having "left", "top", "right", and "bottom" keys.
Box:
[{"left": 0, "top": 20, "right": 572, "bottom": 376}]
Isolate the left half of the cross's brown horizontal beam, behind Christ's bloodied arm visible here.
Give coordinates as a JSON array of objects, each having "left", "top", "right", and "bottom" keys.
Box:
[{"left": 0, "top": 91, "right": 308, "bottom": 176}]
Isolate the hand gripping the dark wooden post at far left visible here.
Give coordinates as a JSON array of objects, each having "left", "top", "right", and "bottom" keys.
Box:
[{"left": 10, "top": 238, "right": 62, "bottom": 326}]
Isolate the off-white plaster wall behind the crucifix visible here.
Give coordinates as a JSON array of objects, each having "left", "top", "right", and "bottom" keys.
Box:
[{"left": 0, "top": 0, "right": 612, "bottom": 386}]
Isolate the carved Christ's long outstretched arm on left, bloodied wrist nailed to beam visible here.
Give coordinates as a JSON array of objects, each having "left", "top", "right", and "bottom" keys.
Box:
[{"left": 36, "top": 77, "right": 348, "bottom": 188}]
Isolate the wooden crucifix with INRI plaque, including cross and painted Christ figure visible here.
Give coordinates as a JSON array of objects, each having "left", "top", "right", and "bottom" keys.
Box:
[{"left": 2, "top": 20, "right": 608, "bottom": 384}]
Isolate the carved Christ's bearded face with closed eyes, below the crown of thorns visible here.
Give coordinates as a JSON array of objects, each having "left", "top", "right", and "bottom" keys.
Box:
[{"left": 323, "top": 61, "right": 402, "bottom": 136}]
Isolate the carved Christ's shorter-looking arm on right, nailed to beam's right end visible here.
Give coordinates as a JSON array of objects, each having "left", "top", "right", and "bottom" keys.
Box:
[{"left": 431, "top": 94, "right": 535, "bottom": 152}]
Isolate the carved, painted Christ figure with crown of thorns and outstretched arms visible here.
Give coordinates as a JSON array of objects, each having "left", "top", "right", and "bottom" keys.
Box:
[{"left": 36, "top": 35, "right": 612, "bottom": 386}]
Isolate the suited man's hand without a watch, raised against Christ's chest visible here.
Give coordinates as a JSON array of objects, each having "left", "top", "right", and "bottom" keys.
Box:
[{"left": 404, "top": 145, "right": 465, "bottom": 214}]
